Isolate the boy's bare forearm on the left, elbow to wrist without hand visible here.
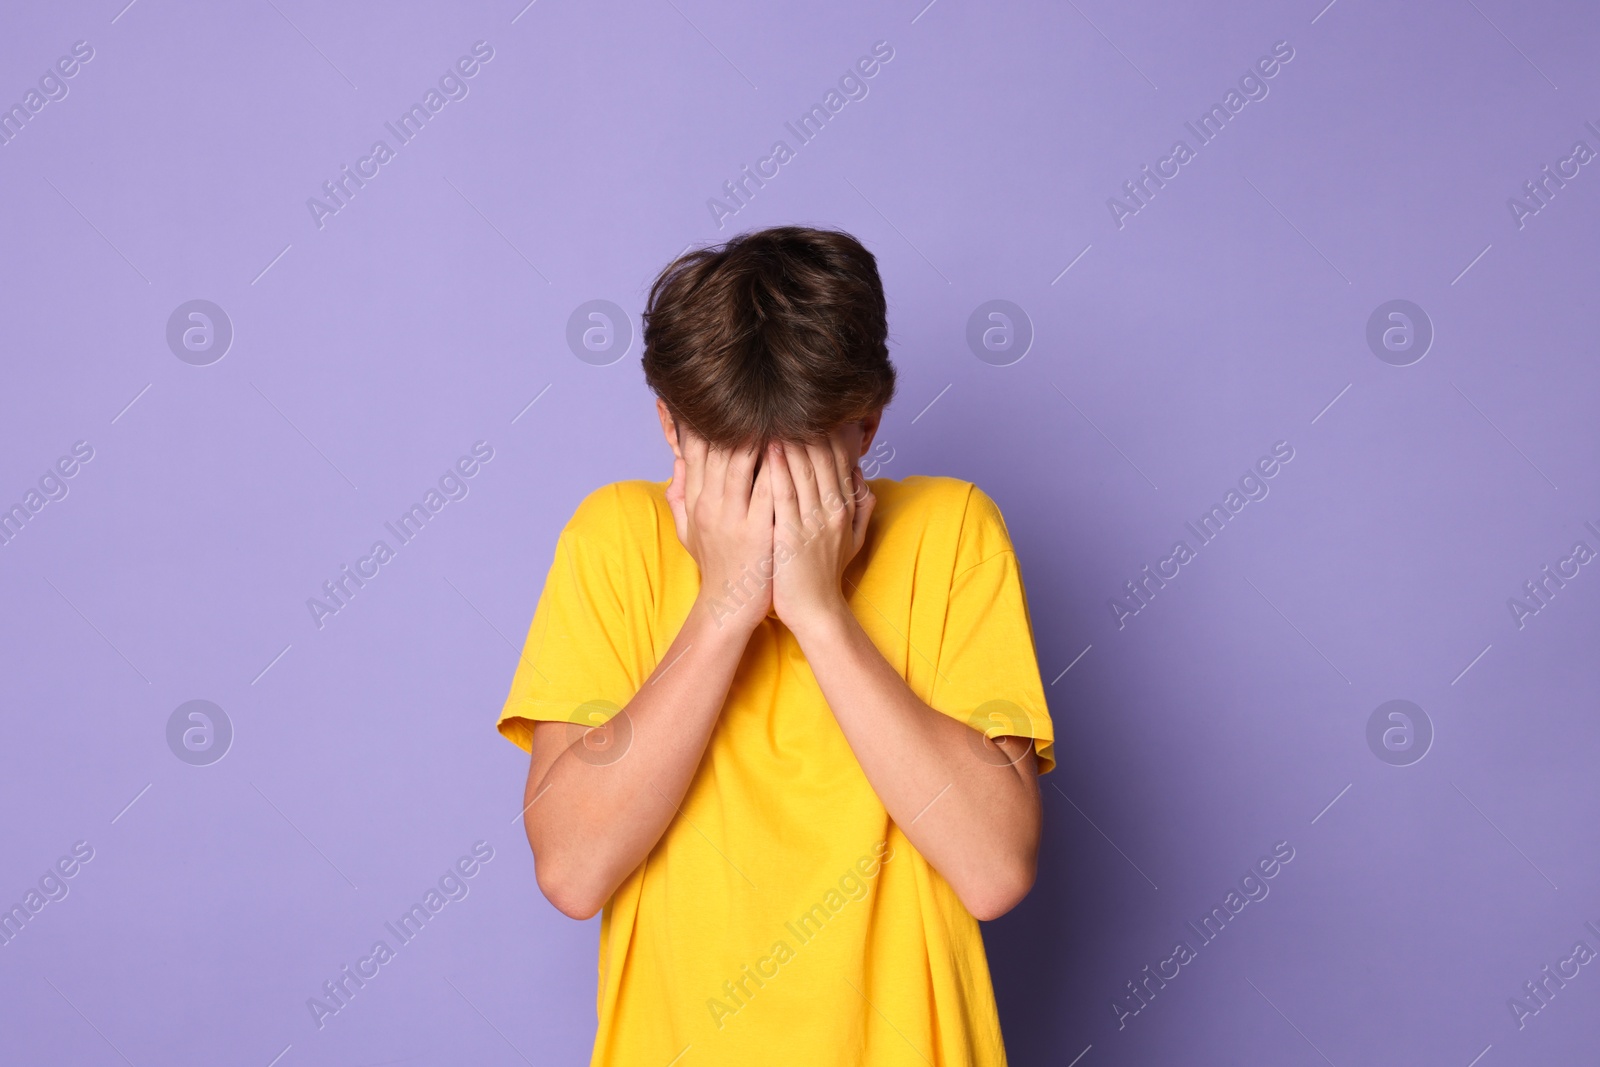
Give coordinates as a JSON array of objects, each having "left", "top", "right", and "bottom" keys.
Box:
[{"left": 523, "top": 601, "right": 750, "bottom": 918}]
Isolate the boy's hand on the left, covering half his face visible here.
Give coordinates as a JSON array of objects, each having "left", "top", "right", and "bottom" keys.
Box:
[{"left": 667, "top": 434, "right": 774, "bottom": 630}]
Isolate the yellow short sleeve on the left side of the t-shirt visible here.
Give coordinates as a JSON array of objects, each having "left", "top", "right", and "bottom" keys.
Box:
[{"left": 496, "top": 494, "right": 642, "bottom": 750}]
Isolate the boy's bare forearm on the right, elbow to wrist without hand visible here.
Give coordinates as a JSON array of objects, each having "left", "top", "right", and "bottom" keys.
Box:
[{"left": 795, "top": 608, "right": 1040, "bottom": 918}]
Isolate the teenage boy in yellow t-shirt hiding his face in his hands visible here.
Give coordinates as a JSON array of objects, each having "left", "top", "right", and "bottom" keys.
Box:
[{"left": 498, "top": 227, "right": 1054, "bottom": 1067}]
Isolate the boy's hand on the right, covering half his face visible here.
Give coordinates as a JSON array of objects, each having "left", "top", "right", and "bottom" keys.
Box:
[{"left": 766, "top": 438, "right": 877, "bottom": 632}]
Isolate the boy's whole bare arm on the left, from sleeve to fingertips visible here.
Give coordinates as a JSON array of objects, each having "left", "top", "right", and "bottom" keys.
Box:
[{"left": 523, "top": 443, "right": 773, "bottom": 918}]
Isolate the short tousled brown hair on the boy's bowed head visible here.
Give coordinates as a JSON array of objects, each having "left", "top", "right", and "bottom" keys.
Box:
[{"left": 643, "top": 226, "right": 894, "bottom": 448}]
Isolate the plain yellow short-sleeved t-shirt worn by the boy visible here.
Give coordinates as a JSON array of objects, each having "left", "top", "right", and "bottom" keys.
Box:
[{"left": 498, "top": 475, "right": 1054, "bottom": 1067}]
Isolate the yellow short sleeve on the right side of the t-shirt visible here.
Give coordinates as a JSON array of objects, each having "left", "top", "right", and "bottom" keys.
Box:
[{"left": 930, "top": 486, "right": 1056, "bottom": 774}]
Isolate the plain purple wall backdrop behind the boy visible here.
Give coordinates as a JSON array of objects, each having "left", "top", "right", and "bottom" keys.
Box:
[{"left": 0, "top": 0, "right": 1600, "bottom": 1067}]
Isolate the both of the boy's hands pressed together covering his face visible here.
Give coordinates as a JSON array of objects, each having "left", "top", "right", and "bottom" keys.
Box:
[{"left": 667, "top": 432, "right": 877, "bottom": 630}]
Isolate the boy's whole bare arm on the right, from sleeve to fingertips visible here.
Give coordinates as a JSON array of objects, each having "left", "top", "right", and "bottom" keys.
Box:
[{"left": 770, "top": 445, "right": 1042, "bottom": 920}]
